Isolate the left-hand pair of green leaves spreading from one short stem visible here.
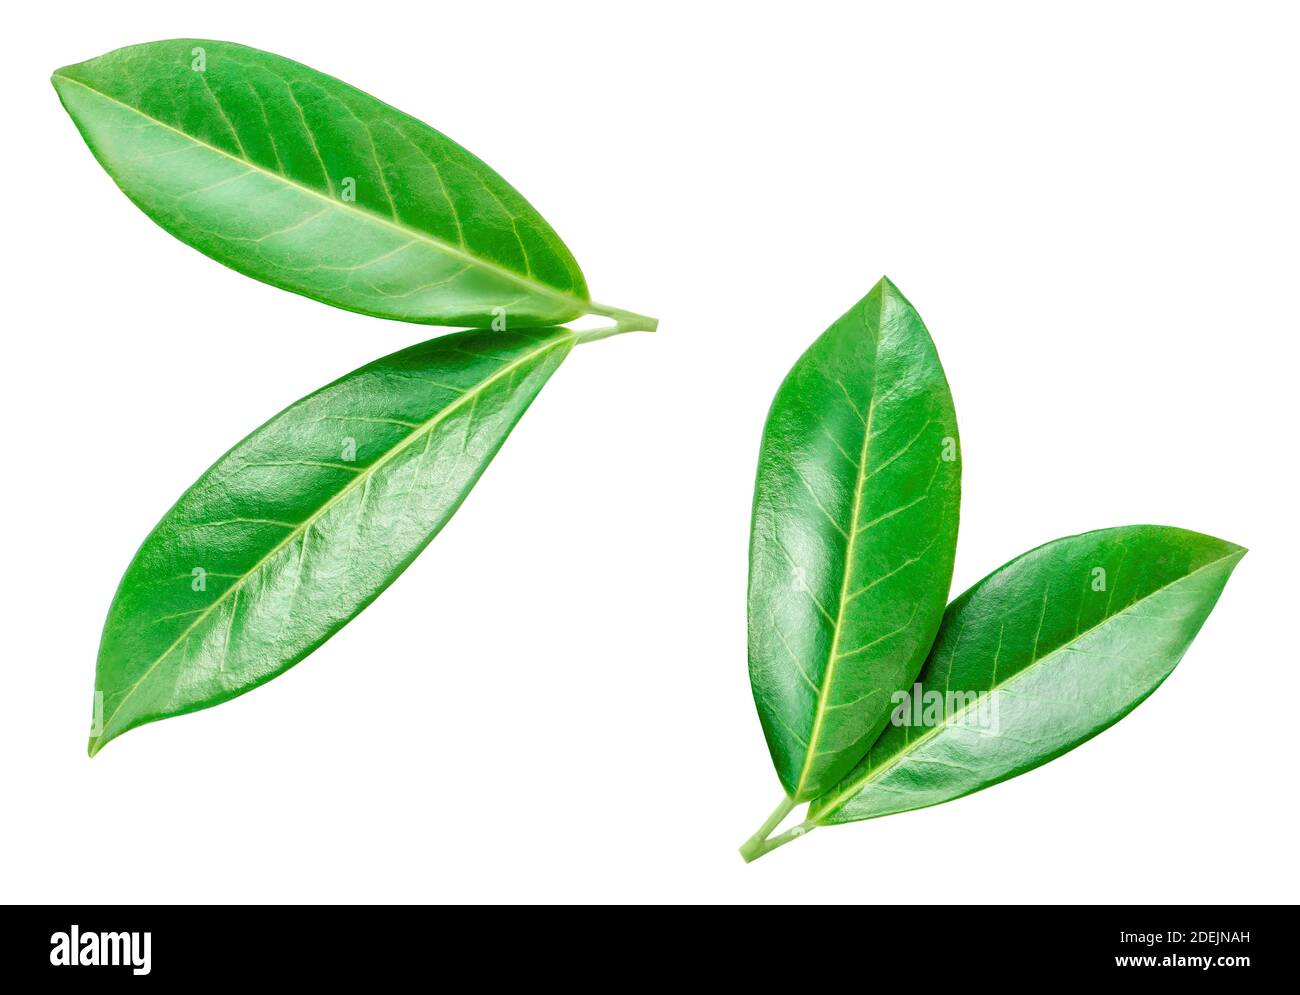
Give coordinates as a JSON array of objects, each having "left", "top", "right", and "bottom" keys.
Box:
[{"left": 53, "top": 39, "right": 657, "bottom": 754}]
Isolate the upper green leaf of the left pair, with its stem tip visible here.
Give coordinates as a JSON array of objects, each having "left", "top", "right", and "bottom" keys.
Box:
[{"left": 53, "top": 39, "right": 653, "bottom": 330}]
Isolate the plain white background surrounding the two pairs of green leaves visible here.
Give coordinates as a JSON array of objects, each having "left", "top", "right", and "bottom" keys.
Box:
[{"left": 0, "top": 0, "right": 1300, "bottom": 903}]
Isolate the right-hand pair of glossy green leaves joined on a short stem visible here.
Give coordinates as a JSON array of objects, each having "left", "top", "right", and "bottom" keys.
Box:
[{"left": 741, "top": 280, "right": 1245, "bottom": 860}]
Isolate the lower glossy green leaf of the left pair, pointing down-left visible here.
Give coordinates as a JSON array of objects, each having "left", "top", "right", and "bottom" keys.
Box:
[{"left": 90, "top": 328, "right": 577, "bottom": 756}]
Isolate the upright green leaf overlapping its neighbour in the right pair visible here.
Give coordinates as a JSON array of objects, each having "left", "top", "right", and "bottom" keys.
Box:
[{"left": 749, "top": 280, "right": 961, "bottom": 801}]
